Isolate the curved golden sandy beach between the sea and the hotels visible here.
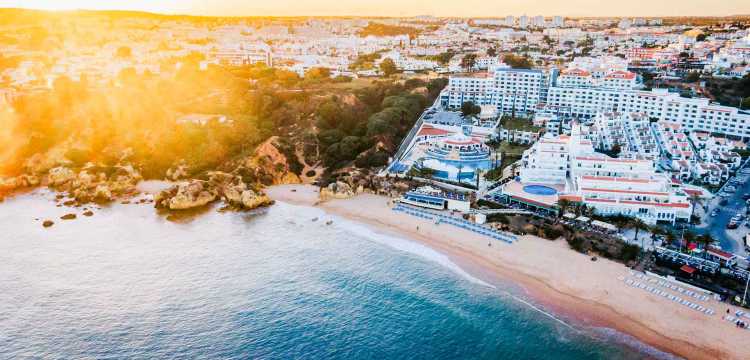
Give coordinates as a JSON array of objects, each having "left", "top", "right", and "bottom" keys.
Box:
[{"left": 267, "top": 185, "right": 750, "bottom": 359}]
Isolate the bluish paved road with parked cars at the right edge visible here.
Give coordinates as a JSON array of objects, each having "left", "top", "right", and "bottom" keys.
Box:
[{"left": 696, "top": 174, "right": 750, "bottom": 255}]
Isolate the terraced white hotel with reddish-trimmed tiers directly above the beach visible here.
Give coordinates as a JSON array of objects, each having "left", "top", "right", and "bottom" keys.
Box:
[{"left": 503, "top": 129, "right": 692, "bottom": 224}]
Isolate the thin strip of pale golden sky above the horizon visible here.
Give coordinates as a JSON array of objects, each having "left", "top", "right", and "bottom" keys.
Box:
[{"left": 0, "top": 0, "right": 750, "bottom": 17}]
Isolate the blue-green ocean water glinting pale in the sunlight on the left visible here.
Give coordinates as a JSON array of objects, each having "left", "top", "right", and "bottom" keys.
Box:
[{"left": 0, "top": 190, "right": 671, "bottom": 360}]
